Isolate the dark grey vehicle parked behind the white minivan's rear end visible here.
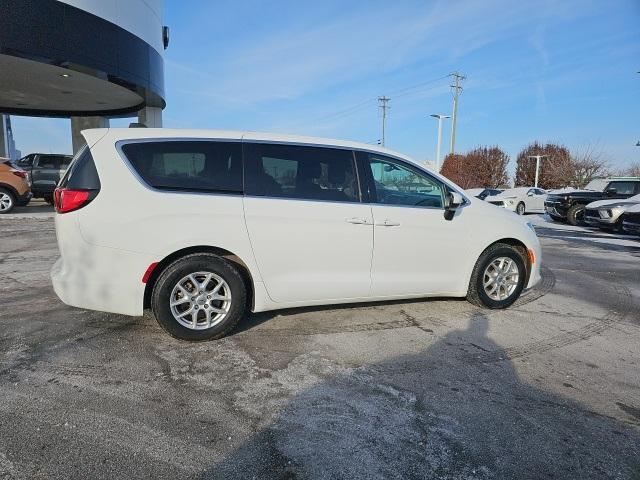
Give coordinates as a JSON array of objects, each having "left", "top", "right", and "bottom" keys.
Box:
[{"left": 16, "top": 153, "right": 72, "bottom": 203}]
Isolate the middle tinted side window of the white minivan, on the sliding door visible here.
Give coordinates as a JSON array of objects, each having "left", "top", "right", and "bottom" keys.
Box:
[{"left": 244, "top": 143, "right": 360, "bottom": 202}]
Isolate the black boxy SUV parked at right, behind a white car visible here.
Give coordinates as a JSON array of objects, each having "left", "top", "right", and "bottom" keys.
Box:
[{"left": 544, "top": 177, "right": 640, "bottom": 225}]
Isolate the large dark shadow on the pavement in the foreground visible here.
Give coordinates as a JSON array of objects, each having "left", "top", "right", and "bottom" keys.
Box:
[{"left": 201, "top": 314, "right": 640, "bottom": 479}]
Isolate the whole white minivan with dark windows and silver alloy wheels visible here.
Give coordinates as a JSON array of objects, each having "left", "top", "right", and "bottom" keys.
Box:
[{"left": 51, "top": 128, "right": 541, "bottom": 340}]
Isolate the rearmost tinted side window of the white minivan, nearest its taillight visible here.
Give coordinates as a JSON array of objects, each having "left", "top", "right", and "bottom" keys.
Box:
[{"left": 122, "top": 140, "right": 243, "bottom": 193}]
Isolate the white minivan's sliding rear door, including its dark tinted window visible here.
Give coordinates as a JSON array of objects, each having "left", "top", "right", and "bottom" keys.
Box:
[{"left": 243, "top": 143, "right": 373, "bottom": 303}]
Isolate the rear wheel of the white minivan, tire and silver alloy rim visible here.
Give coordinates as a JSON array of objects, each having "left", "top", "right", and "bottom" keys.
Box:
[{"left": 151, "top": 253, "right": 247, "bottom": 341}]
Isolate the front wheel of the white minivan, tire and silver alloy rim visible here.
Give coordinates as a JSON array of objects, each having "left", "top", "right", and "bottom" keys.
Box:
[{"left": 467, "top": 243, "right": 527, "bottom": 309}]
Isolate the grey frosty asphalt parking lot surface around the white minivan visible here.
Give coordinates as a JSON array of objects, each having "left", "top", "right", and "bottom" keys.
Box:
[{"left": 0, "top": 212, "right": 640, "bottom": 479}]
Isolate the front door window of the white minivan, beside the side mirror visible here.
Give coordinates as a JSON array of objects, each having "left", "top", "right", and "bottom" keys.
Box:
[{"left": 369, "top": 154, "right": 445, "bottom": 208}]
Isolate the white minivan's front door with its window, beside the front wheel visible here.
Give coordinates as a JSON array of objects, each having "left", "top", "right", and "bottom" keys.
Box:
[{"left": 362, "top": 154, "right": 472, "bottom": 297}]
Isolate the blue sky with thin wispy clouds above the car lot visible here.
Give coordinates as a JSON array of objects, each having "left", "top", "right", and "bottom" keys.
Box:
[{"left": 12, "top": 0, "right": 640, "bottom": 176}]
